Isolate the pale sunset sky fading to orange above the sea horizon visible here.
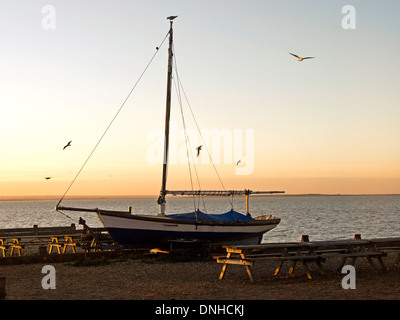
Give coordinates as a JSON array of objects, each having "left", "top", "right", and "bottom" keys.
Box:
[{"left": 0, "top": 0, "right": 400, "bottom": 197}]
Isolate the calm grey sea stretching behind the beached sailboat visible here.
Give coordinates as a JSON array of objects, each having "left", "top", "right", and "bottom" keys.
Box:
[{"left": 0, "top": 195, "right": 400, "bottom": 242}]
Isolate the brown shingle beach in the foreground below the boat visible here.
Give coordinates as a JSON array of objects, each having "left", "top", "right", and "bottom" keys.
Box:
[{"left": 0, "top": 254, "right": 400, "bottom": 300}]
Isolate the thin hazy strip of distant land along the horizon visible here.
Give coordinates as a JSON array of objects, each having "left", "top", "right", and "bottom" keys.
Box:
[{"left": 0, "top": 193, "right": 400, "bottom": 201}]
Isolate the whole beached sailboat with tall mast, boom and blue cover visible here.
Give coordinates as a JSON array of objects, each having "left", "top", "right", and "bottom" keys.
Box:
[{"left": 56, "top": 16, "right": 284, "bottom": 247}]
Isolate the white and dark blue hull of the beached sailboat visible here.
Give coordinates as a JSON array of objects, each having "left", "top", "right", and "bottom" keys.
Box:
[{"left": 98, "top": 211, "right": 280, "bottom": 247}]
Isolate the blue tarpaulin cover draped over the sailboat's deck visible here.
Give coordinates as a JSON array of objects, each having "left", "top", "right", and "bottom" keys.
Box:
[{"left": 166, "top": 210, "right": 253, "bottom": 222}]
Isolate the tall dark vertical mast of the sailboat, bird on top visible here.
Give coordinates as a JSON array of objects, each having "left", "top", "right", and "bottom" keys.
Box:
[{"left": 157, "top": 16, "right": 177, "bottom": 216}]
